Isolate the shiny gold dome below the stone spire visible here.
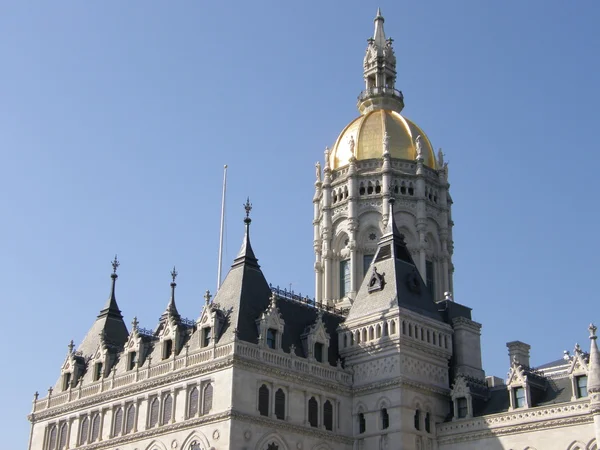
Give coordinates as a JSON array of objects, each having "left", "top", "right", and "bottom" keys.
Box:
[{"left": 329, "top": 109, "right": 436, "bottom": 170}]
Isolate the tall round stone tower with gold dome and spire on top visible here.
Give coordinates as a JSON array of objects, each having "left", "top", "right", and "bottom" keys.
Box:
[{"left": 313, "top": 10, "right": 454, "bottom": 306}]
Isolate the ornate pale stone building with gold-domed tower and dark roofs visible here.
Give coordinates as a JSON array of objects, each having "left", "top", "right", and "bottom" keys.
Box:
[{"left": 28, "top": 12, "right": 600, "bottom": 450}]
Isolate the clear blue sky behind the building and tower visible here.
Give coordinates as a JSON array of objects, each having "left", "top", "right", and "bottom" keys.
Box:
[{"left": 0, "top": 0, "right": 600, "bottom": 449}]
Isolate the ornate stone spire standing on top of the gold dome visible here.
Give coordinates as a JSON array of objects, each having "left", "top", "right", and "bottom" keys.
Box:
[{"left": 358, "top": 9, "right": 404, "bottom": 114}]
